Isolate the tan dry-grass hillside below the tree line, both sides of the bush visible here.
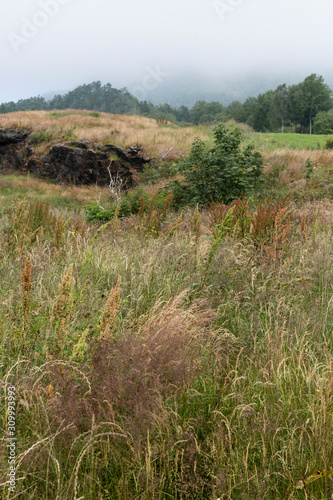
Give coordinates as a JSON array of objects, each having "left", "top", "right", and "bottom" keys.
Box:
[{"left": 0, "top": 110, "right": 331, "bottom": 157}]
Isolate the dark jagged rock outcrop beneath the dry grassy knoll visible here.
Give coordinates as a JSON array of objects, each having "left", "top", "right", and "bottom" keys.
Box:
[{"left": 0, "top": 129, "right": 153, "bottom": 188}]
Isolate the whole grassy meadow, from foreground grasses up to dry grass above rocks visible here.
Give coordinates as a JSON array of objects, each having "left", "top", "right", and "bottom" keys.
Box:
[{"left": 0, "top": 112, "right": 333, "bottom": 500}]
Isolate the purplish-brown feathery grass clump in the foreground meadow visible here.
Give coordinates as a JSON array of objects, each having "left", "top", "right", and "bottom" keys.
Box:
[{"left": 92, "top": 292, "right": 215, "bottom": 436}]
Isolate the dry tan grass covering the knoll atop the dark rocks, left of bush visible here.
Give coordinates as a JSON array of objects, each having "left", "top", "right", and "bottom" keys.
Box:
[{"left": 0, "top": 110, "right": 212, "bottom": 158}]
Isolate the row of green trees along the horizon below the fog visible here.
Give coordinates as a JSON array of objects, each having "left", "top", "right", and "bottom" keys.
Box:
[{"left": 0, "top": 74, "right": 333, "bottom": 134}]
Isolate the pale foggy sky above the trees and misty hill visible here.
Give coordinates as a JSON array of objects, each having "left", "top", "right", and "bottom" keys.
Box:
[{"left": 0, "top": 0, "right": 333, "bottom": 102}]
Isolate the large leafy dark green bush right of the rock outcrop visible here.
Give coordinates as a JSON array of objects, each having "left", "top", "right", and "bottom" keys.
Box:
[{"left": 167, "top": 124, "right": 263, "bottom": 205}]
